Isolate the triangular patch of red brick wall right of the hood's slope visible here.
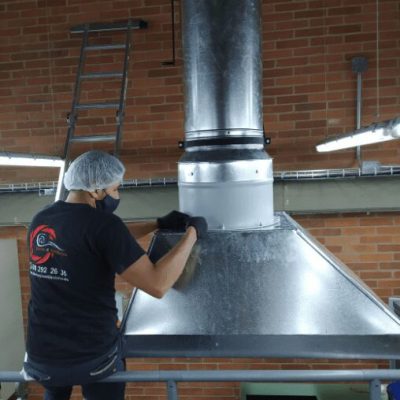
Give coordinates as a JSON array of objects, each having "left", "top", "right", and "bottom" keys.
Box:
[{"left": 296, "top": 213, "right": 400, "bottom": 303}]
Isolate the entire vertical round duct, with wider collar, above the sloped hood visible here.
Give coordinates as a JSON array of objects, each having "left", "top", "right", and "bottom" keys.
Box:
[{"left": 178, "top": 0, "right": 273, "bottom": 230}]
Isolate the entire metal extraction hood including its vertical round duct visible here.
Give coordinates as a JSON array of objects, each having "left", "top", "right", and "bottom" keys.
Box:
[{"left": 123, "top": 0, "right": 400, "bottom": 359}]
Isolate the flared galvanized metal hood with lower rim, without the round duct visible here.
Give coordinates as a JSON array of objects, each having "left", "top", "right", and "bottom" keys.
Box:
[{"left": 124, "top": 214, "right": 400, "bottom": 359}]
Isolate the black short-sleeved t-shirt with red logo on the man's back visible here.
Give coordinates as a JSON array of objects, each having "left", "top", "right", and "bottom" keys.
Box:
[{"left": 27, "top": 201, "right": 145, "bottom": 365}]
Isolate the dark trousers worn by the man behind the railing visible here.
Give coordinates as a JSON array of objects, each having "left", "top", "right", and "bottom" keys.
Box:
[{"left": 24, "top": 345, "right": 125, "bottom": 400}]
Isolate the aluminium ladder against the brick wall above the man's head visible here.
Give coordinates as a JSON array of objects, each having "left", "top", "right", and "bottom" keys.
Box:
[{"left": 63, "top": 20, "right": 147, "bottom": 159}]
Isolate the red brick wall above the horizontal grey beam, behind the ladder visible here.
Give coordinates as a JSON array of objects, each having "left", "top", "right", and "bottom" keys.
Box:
[{"left": 0, "top": 0, "right": 400, "bottom": 182}]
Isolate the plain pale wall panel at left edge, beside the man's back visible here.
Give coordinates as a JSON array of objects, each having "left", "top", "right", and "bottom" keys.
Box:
[{"left": 0, "top": 239, "right": 25, "bottom": 399}]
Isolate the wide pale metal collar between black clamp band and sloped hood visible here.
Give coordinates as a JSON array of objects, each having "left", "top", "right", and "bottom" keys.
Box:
[{"left": 178, "top": 150, "right": 273, "bottom": 229}]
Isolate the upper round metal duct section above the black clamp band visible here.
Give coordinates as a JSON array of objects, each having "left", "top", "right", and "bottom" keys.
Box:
[{"left": 182, "top": 0, "right": 263, "bottom": 140}]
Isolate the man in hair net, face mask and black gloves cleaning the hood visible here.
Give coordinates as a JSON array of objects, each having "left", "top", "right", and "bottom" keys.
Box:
[{"left": 24, "top": 151, "right": 207, "bottom": 400}]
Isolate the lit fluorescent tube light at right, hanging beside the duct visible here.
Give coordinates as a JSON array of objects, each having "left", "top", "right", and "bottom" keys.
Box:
[{"left": 316, "top": 117, "right": 400, "bottom": 152}]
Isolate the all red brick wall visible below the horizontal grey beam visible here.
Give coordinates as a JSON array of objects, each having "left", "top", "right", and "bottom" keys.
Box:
[{"left": 0, "top": 213, "right": 400, "bottom": 400}]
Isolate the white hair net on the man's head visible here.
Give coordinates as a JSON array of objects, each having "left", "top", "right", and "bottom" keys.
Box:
[{"left": 64, "top": 150, "right": 125, "bottom": 192}]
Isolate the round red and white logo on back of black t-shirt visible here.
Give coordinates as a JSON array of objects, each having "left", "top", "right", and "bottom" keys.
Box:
[{"left": 29, "top": 225, "right": 67, "bottom": 265}]
